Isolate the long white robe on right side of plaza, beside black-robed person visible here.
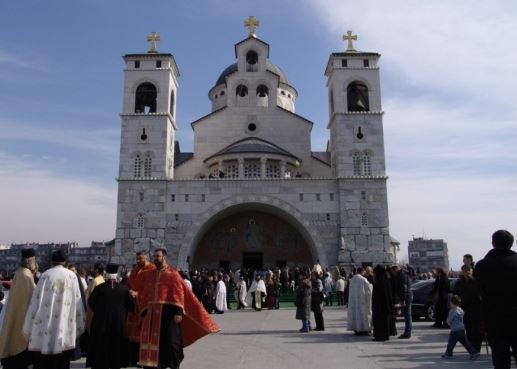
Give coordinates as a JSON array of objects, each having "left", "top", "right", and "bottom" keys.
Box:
[{"left": 347, "top": 274, "right": 373, "bottom": 332}]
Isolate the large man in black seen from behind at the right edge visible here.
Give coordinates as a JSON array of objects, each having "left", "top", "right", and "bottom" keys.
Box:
[{"left": 474, "top": 230, "right": 517, "bottom": 369}]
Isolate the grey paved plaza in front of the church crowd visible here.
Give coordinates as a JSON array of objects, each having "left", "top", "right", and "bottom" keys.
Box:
[{"left": 72, "top": 308, "right": 492, "bottom": 369}]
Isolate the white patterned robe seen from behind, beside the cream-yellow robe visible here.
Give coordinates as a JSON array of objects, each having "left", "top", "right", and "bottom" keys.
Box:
[{"left": 23, "top": 265, "right": 86, "bottom": 355}]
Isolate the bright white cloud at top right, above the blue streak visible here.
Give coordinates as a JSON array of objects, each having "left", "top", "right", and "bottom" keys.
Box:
[{"left": 305, "top": 0, "right": 517, "bottom": 112}]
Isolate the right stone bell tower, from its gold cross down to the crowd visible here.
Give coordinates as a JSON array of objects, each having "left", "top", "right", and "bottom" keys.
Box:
[{"left": 325, "top": 31, "right": 394, "bottom": 266}]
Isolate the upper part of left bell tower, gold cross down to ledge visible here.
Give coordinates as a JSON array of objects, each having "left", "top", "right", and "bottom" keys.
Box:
[{"left": 119, "top": 32, "right": 179, "bottom": 180}]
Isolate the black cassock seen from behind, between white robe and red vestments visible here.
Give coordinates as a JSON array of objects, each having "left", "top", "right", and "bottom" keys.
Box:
[{"left": 86, "top": 281, "right": 133, "bottom": 369}]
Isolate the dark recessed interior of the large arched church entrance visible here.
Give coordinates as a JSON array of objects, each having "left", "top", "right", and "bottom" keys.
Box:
[{"left": 190, "top": 204, "right": 315, "bottom": 269}]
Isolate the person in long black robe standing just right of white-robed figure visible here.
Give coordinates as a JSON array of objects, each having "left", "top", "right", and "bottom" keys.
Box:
[{"left": 372, "top": 265, "right": 393, "bottom": 341}]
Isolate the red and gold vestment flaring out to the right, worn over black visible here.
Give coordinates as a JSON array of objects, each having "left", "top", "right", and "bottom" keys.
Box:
[{"left": 139, "top": 266, "right": 219, "bottom": 366}]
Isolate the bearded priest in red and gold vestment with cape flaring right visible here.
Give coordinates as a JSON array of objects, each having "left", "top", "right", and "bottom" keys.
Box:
[{"left": 138, "top": 249, "right": 219, "bottom": 369}]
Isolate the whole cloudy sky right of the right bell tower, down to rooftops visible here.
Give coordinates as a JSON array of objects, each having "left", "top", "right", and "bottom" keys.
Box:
[{"left": 305, "top": 0, "right": 517, "bottom": 267}]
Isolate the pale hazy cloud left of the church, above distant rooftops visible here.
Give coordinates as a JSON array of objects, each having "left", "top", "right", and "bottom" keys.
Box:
[{"left": 0, "top": 152, "right": 116, "bottom": 246}]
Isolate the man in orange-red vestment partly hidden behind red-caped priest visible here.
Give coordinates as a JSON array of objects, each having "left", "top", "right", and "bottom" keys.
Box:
[{"left": 127, "top": 251, "right": 156, "bottom": 366}]
